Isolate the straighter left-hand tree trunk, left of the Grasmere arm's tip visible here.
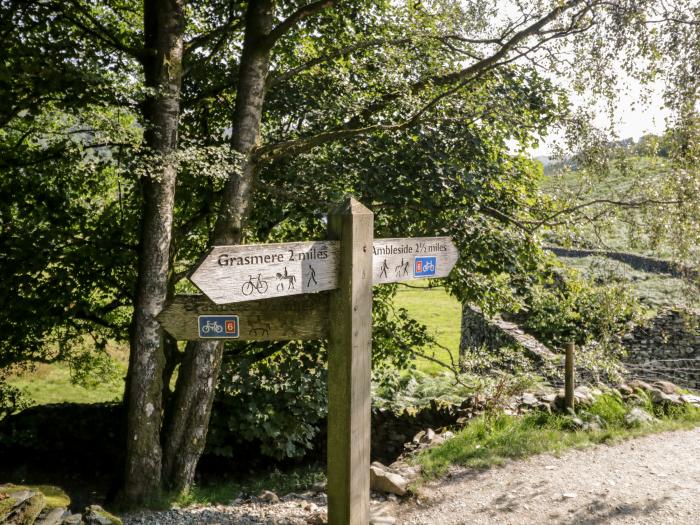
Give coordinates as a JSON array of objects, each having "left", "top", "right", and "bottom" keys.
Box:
[{"left": 123, "top": 0, "right": 184, "bottom": 505}]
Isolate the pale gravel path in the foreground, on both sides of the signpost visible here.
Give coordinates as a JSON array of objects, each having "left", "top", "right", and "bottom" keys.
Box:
[{"left": 125, "top": 428, "right": 700, "bottom": 525}]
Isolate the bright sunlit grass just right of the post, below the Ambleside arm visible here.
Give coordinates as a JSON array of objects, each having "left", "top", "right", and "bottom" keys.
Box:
[{"left": 395, "top": 281, "right": 462, "bottom": 375}]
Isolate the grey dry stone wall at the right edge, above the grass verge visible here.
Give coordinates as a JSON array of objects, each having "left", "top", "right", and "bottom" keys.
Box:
[{"left": 622, "top": 308, "right": 700, "bottom": 390}]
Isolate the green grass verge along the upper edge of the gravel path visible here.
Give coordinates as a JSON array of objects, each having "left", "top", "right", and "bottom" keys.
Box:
[{"left": 415, "top": 394, "right": 700, "bottom": 478}]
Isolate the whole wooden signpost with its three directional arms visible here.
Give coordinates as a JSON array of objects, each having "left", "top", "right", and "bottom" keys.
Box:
[{"left": 158, "top": 198, "right": 458, "bottom": 525}]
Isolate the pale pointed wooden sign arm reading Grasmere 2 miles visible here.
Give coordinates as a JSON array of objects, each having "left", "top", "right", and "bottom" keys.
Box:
[{"left": 190, "top": 241, "right": 338, "bottom": 304}]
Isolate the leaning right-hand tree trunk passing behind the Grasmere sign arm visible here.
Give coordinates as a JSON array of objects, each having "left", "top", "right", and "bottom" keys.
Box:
[{"left": 163, "top": 0, "right": 272, "bottom": 491}]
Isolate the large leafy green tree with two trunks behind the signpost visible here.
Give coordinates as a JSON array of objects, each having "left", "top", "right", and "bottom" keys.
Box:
[{"left": 2, "top": 0, "right": 628, "bottom": 503}]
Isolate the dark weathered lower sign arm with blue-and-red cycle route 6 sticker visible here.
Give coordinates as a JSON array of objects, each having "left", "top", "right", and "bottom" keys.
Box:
[{"left": 157, "top": 293, "right": 329, "bottom": 341}]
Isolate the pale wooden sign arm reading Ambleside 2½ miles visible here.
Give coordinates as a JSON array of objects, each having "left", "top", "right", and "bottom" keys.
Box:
[{"left": 372, "top": 237, "right": 459, "bottom": 284}]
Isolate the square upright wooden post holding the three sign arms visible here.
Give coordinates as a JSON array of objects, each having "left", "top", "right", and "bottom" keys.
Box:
[{"left": 327, "top": 198, "right": 374, "bottom": 525}]
